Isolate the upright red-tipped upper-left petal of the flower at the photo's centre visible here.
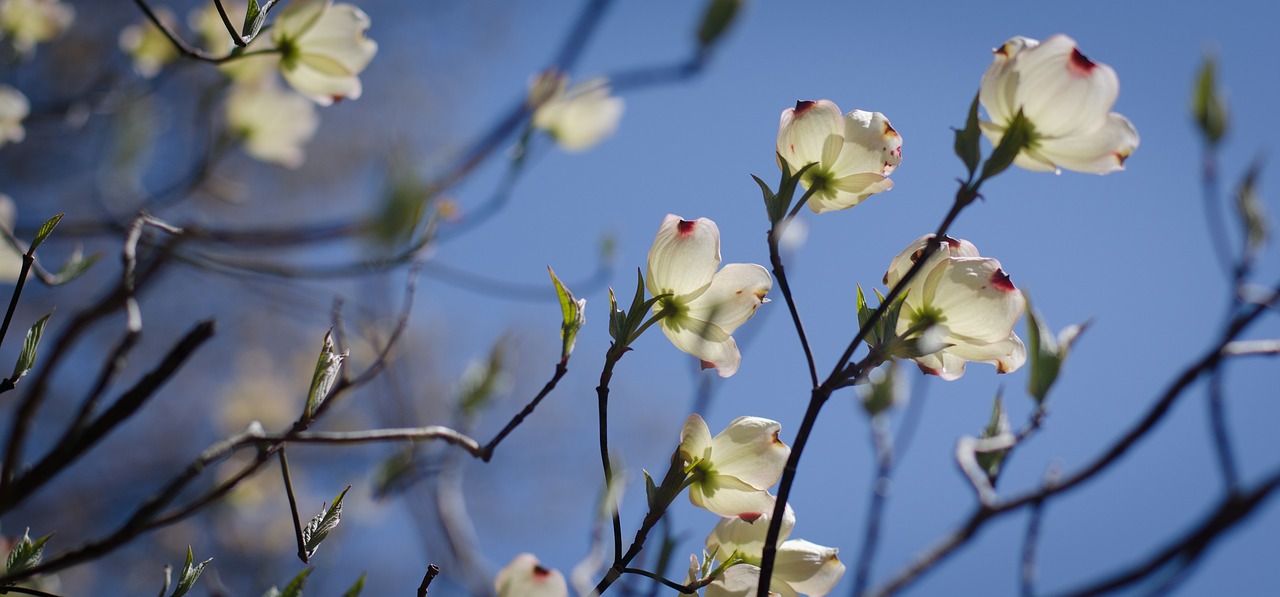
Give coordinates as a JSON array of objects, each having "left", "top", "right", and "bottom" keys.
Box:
[{"left": 645, "top": 214, "right": 721, "bottom": 301}]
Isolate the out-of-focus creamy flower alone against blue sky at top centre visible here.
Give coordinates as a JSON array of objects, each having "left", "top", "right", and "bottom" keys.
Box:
[{"left": 530, "top": 73, "right": 623, "bottom": 151}]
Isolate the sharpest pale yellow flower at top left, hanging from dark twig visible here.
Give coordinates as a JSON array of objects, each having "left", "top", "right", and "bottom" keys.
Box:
[{"left": 271, "top": 0, "right": 378, "bottom": 106}]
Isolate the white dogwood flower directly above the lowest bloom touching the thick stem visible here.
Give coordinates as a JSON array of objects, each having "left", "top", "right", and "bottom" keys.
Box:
[{"left": 678, "top": 414, "right": 791, "bottom": 520}]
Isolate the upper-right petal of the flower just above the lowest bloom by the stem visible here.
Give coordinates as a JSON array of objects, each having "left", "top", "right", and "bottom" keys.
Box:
[{"left": 712, "top": 416, "right": 791, "bottom": 489}]
